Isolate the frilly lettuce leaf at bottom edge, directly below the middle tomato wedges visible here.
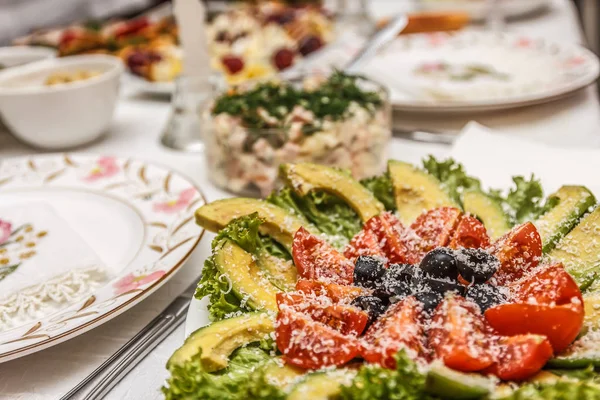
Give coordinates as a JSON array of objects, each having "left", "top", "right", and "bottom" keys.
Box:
[{"left": 340, "top": 350, "right": 436, "bottom": 400}]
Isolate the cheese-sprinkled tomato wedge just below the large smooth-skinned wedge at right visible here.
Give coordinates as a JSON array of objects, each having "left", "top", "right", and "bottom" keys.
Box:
[{"left": 483, "top": 335, "right": 552, "bottom": 381}]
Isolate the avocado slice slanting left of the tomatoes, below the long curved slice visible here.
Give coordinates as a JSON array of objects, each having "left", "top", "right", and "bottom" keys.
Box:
[{"left": 213, "top": 239, "right": 280, "bottom": 312}]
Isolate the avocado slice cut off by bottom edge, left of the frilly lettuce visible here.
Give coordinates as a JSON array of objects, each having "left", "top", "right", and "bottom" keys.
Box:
[{"left": 287, "top": 369, "right": 356, "bottom": 400}]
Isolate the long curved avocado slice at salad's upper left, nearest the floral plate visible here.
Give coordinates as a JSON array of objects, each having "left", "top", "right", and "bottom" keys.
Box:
[{"left": 196, "top": 197, "right": 318, "bottom": 253}]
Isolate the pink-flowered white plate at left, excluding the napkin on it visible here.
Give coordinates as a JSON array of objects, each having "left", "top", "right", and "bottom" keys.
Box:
[{"left": 0, "top": 154, "right": 205, "bottom": 362}]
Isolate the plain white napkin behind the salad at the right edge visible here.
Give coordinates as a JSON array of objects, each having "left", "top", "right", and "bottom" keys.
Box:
[{"left": 451, "top": 122, "right": 600, "bottom": 197}]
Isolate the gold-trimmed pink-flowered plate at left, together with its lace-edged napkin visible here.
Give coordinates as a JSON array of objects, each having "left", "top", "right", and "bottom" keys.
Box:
[{"left": 0, "top": 154, "right": 205, "bottom": 362}]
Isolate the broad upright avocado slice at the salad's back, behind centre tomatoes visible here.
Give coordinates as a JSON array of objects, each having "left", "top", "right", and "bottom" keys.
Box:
[{"left": 388, "top": 160, "right": 460, "bottom": 225}]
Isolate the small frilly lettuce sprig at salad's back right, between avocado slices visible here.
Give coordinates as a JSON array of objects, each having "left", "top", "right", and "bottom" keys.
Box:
[{"left": 490, "top": 175, "right": 559, "bottom": 224}]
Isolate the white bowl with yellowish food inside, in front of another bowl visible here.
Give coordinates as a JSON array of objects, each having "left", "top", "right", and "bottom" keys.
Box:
[{"left": 0, "top": 55, "right": 124, "bottom": 149}]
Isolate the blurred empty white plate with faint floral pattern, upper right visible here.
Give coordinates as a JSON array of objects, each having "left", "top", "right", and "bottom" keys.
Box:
[{"left": 363, "top": 31, "right": 600, "bottom": 112}]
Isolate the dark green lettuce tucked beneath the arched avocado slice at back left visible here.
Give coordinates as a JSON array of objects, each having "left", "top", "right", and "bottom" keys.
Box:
[{"left": 267, "top": 187, "right": 362, "bottom": 248}]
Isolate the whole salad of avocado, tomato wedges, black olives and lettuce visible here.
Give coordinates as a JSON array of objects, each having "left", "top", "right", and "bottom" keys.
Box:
[{"left": 163, "top": 158, "right": 600, "bottom": 400}]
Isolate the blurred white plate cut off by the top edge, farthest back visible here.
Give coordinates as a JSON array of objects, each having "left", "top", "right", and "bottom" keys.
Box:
[{"left": 419, "top": 0, "right": 552, "bottom": 20}]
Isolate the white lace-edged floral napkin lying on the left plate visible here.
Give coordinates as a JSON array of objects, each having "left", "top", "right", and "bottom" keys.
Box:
[{"left": 0, "top": 202, "right": 107, "bottom": 331}]
